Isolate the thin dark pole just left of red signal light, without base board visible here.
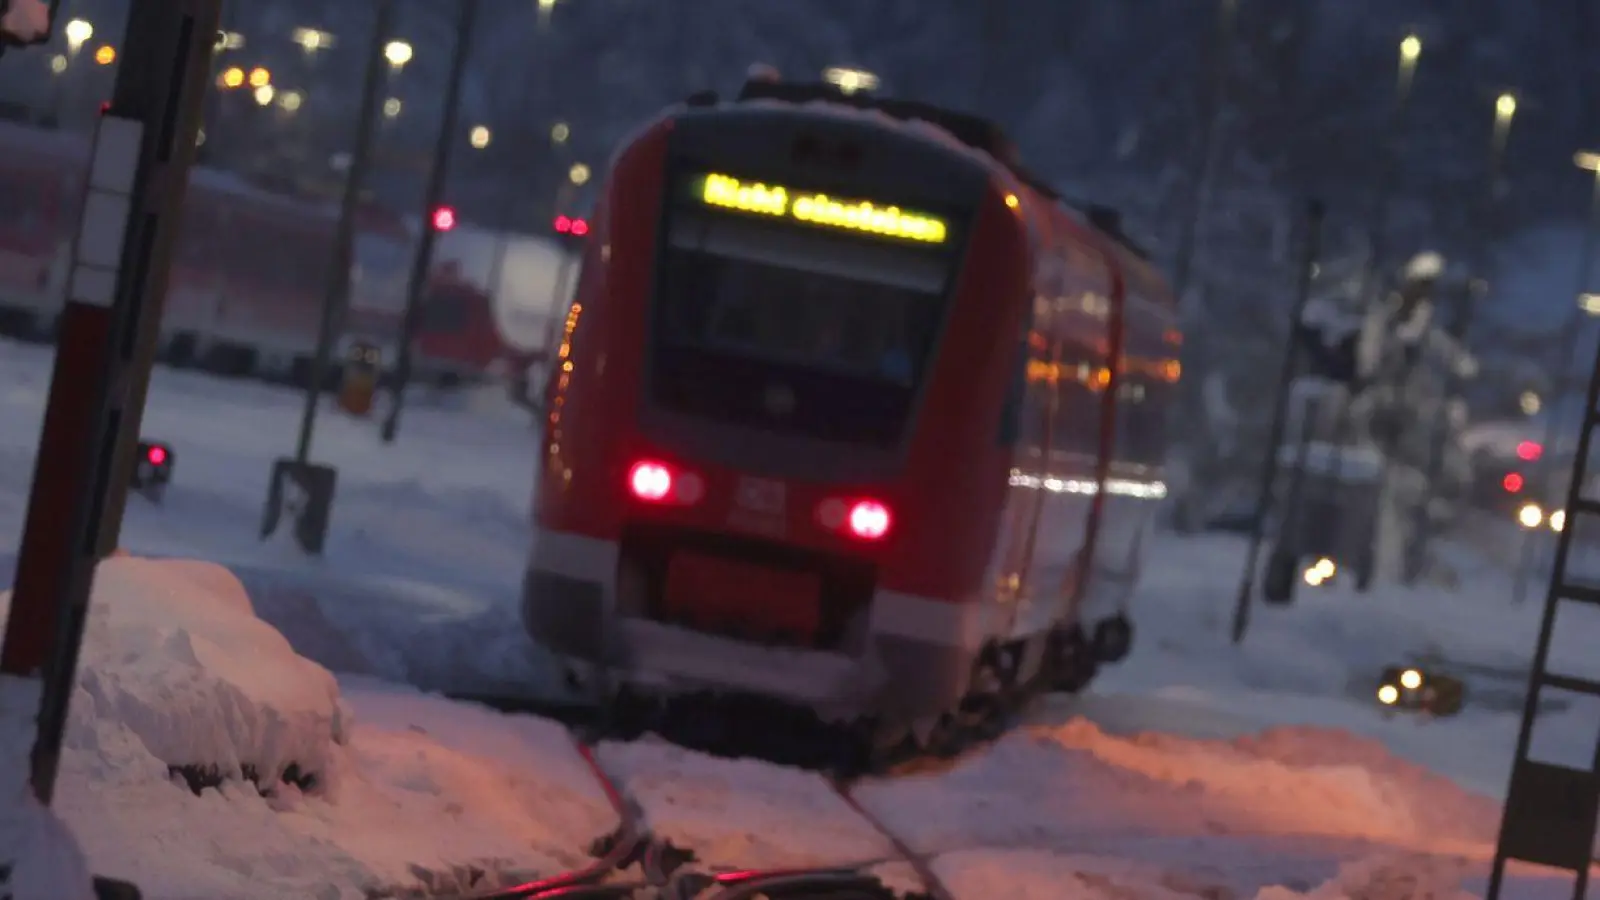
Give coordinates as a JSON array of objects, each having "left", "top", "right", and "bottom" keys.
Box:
[{"left": 382, "top": 0, "right": 478, "bottom": 444}]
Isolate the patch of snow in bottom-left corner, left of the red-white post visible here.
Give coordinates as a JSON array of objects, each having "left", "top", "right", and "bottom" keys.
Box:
[{"left": 0, "top": 676, "right": 94, "bottom": 900}]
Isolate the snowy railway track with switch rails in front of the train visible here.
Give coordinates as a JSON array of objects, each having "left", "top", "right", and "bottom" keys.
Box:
[{"left": 441, "top": 695, "right": 1003, "bottom": 900}]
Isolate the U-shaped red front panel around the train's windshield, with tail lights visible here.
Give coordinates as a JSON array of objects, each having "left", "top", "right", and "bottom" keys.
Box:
[{"left": 536, "top": 115, "right": 1030, "bottom": 618}]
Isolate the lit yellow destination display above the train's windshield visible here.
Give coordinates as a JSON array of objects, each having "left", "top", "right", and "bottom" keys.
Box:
[{"left": 699, "top": 173, "right": 949, "bottom": 243}]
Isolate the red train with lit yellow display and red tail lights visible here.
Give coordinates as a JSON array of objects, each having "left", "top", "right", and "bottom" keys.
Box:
[{"left": 522, "top": 82, "right": 1181, "bottom": 740}]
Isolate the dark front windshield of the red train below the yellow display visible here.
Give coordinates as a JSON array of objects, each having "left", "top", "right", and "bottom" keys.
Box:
[{"left": 651, "top": 168, "right": 958, "bottom": 445}]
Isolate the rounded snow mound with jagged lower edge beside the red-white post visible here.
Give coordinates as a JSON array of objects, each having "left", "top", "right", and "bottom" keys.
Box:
[{"left": 0, "top": 556, "right": 347, "bottom": 791}]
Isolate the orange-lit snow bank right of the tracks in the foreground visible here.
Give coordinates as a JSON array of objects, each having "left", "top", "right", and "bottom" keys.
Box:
[{"left": 858, "top": 719, "right": 1498, "bottom": 900}]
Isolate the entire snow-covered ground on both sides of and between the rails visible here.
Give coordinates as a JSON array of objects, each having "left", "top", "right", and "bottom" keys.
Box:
[{"left": 0, "top": 337, "right": 1600, "bottom": 900}]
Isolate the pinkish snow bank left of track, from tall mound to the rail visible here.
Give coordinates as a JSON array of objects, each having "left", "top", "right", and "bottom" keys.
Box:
[{"left": 0, "top": 557, "right": 616, "bottom": 900}]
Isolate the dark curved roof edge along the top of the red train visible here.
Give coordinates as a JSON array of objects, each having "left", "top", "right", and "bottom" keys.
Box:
[{"left": 723, "top": 78, "right": 1150, "bottom": 263}]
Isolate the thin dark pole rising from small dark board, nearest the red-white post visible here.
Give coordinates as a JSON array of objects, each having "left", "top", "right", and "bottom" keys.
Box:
[{"left": 294, "top": 0, "right": 395, "bottom": 464}]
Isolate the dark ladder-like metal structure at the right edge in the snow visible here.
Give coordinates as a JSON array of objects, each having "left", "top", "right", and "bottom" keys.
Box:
[{"left": 1485, "top": 325, "right": 1600, "bottom": 900}]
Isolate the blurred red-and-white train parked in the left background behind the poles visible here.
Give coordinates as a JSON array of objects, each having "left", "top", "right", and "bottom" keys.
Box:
[{"left": 0, "top": 114, "right": 528, "bottom": 380}]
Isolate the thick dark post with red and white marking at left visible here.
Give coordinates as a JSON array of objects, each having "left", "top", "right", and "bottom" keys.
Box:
[{"left": 0, "top": 0, "right": 221, "bottom": 804}]
